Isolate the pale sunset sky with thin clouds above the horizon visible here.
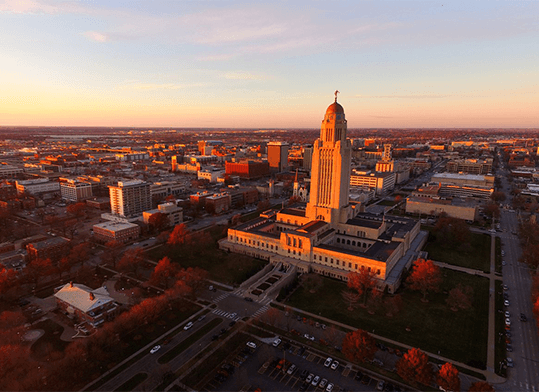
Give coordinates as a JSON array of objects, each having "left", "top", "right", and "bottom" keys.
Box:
[{"left": 0, "top": 0, "right": 539, "bottom": 129}]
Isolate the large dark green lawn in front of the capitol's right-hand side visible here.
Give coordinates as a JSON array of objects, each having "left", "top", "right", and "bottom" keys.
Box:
[{"left": 286, "top": 269, "right": 489, "bottom": 367}]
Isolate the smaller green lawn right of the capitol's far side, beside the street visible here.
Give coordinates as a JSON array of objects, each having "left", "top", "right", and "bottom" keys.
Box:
[{"left": 424, "top": 233, "right": 491, "bottom": 273}]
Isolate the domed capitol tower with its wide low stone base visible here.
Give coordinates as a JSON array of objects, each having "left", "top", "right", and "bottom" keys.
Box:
[{"left": 219, "top": 94, "right": 427, "bottom": 292}]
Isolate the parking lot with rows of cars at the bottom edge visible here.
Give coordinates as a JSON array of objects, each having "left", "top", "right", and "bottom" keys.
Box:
[{"left": 204, "top": 340, "right": 400, "bottom": 392}]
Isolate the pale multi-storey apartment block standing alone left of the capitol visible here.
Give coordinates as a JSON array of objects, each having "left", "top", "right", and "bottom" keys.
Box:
[{"left": 109, "top": 180, "right": 152, "bottom": 217}]
